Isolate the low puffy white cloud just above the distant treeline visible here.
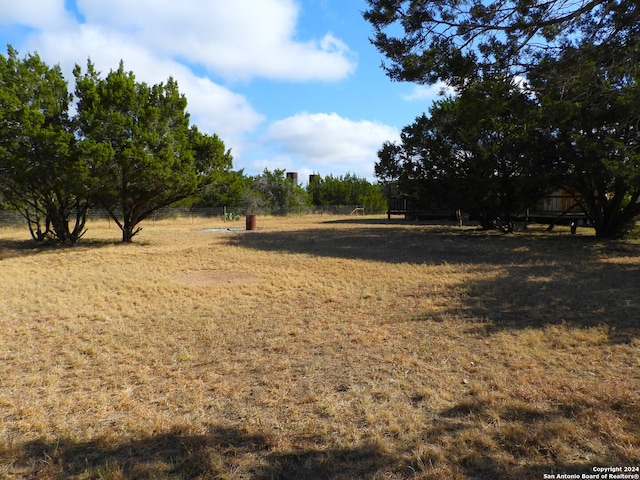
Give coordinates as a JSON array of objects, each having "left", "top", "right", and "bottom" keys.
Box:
[{"left": 265, "top": 112, "right": 399, "bottom": 178}]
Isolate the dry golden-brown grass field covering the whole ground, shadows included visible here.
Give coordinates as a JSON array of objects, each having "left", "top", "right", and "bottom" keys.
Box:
[{"left": 0, "top": 216, "right": 640, "bottom": 480}]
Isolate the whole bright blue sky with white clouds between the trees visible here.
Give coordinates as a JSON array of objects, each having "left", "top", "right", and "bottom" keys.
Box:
[{"left": 0, "top": 0, "right": 448, "bottom": 183}]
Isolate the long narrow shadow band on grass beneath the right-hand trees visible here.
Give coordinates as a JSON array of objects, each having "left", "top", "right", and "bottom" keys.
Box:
[{"left": 229, "top": 221, "right": 640, "bottom": 265}]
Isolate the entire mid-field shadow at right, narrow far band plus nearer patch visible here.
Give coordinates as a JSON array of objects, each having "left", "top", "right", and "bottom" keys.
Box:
[{"left": 229, "top": 224, "right": 640, "bottom": 342}]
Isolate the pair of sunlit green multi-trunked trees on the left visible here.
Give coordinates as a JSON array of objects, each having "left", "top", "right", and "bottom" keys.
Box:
[{"left": 0, "top": 47, "right": 237, "bottom": 243}]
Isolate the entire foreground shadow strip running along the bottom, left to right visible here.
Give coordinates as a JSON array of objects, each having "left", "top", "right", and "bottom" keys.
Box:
[{"left": 10, "top": 418, "right": 633, "bottom": 480}]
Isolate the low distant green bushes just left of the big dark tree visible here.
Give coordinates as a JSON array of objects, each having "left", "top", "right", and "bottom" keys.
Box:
[{"left": 307, "top": 173, "right": 387, "bottom": 213}]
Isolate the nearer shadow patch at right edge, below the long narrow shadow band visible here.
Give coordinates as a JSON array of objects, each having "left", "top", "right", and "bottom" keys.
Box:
[{"left": 460, "top": 258, "right": 640, "bottom": 343}]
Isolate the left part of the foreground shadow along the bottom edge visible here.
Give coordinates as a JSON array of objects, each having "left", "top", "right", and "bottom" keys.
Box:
[{"left": 6, "top": 426, "right": 392, "bottom": 480}]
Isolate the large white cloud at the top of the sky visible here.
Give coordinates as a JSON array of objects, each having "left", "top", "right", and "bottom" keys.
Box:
[{"left": 73, "top": 0, "right": 355, "bottom": 81}]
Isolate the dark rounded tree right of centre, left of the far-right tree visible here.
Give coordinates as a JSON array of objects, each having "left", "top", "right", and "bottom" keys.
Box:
[{"left": 376, "top": 79, "right": 559, "bottom": 231}]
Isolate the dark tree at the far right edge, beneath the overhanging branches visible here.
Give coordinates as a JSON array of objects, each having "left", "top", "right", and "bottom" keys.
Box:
[{"left": 532, "top": 44, "right": 640, "bottom": 238}]
